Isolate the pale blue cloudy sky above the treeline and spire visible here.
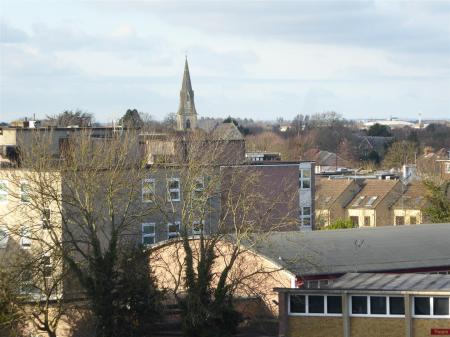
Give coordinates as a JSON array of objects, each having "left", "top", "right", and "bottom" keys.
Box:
[{"left": 0, "top": 0, "right": 450, "bottom": 122}]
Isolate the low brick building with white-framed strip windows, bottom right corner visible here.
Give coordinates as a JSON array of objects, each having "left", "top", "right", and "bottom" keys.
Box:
[{"left": 277, "top": 273, "right": 450, "bottom": 337}]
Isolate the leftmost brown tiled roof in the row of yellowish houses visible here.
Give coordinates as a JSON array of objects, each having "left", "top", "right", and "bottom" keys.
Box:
[{"left": 315, "top": 178, "right": 353, "bottom": 208}]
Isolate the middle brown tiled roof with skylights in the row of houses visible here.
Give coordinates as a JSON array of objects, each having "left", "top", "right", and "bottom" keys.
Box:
[{"left": 349, "top": 179, "right": 401, "bottom": 208}]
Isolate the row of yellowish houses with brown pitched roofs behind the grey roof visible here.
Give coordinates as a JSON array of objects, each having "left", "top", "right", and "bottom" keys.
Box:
[{"left": 315, "top": 178, "right": 427, "bottom": 227}]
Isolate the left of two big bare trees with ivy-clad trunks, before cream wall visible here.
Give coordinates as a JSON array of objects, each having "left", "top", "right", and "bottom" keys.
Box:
[{"left": 3, "top": 131, "right": 162, "bottom": 337}]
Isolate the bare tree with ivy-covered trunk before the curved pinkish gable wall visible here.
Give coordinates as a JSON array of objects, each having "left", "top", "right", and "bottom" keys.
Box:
[{"left": 150, "top": 133, "right": 296, "bottom": 336}]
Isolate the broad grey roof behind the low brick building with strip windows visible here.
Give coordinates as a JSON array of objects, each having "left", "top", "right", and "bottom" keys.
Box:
[{"left": 252, "top": 224, "right": 450, "bottom": 276}]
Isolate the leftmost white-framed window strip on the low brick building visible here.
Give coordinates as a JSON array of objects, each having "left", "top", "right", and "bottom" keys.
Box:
[{"left": 289, "top": 294, "right": 342, "bottom": 316}]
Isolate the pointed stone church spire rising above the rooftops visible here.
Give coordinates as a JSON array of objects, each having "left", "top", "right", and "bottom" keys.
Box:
[{"left": 177, "top": 58, "right": 197, "bottom": 131}]
